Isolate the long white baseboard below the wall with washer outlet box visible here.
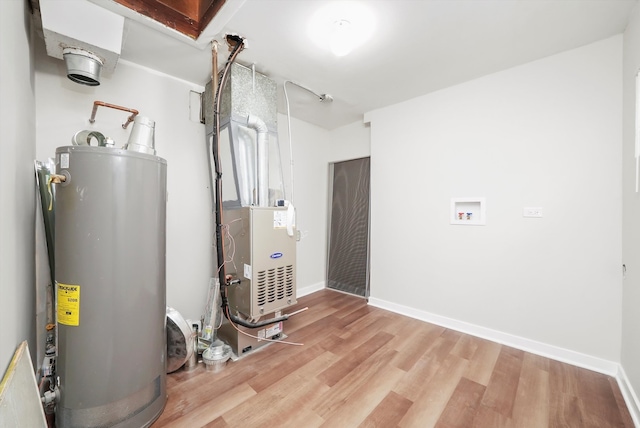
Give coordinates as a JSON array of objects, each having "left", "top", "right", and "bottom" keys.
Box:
[{"left": 369, "top": 297, "right": 620, "bottom": 377}]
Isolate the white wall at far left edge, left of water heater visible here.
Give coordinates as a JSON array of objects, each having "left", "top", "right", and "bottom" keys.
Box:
[{"left": 0, "top": 0, "right": 36, "bottom": 372}]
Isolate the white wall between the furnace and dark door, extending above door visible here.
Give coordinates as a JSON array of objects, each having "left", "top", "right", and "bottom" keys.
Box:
[{"left": 278, "top": 115, "right": 369, "bottom": 294}]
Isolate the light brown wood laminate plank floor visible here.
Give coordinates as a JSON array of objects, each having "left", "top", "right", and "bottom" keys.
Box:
[{"left": 152, "top": 290, "right": 633, "bottom": 428}]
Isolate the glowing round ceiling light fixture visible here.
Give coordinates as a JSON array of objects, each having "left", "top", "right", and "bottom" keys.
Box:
[{"left": 307, "top": 1, "right": 375, "bottom": 56}]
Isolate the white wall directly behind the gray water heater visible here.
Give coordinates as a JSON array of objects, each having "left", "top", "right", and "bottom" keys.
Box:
[{"left": 36, "top": 39, "right": 213, "bottom": 319}]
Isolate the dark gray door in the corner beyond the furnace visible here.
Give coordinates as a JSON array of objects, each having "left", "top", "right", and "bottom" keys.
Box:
[{"left": 327, "top": 157, "right": 369, "bottom": 297}]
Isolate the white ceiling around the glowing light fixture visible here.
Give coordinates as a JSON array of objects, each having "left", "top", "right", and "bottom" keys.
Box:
[{"left": 91, "top": 0, "right": 637, "bottom": 129}]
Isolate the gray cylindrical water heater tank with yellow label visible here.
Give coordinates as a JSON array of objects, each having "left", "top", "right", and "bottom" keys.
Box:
[{"left": 54, "top": 146, "right": 167, "bottom": 428}]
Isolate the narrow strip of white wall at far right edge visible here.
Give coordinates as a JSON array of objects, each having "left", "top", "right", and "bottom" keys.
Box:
[{"left": 622, "top": 1, "right": 640, "bottom": 424}]
